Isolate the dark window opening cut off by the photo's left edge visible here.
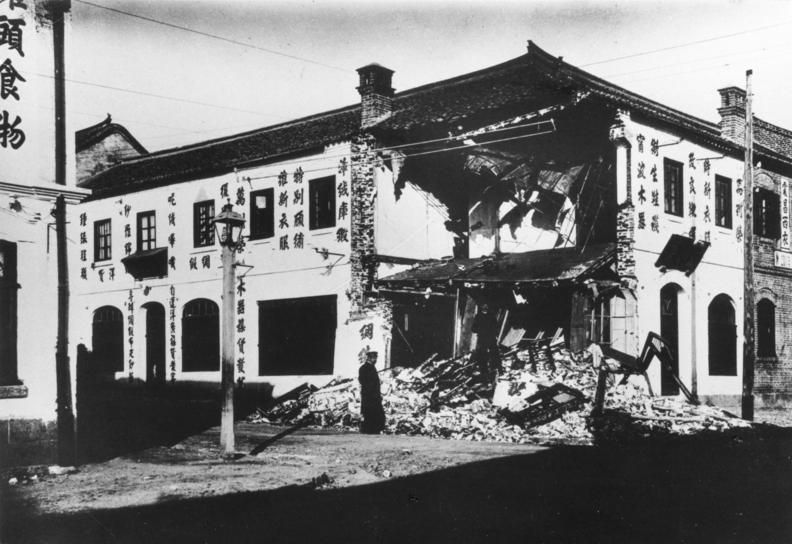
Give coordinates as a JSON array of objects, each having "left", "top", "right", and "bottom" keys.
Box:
[{"left": 0, "top": 240, "right": 20, "bottom": 385}]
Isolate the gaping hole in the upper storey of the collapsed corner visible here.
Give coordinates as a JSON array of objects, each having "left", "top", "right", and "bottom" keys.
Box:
[{"left": 395, "top": 99, "right": 616, "bottom": 258}]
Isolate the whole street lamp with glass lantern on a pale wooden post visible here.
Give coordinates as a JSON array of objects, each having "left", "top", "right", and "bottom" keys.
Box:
[{"left": 213, "top": 202, "right": 245, "bottom": 455}]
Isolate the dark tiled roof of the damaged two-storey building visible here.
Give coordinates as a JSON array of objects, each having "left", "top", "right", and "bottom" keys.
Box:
[{"left": 83, "top": 42, "right": 792, "bottom": 198}]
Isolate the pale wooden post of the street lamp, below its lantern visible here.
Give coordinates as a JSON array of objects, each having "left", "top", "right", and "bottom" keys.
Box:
[{"left": 220, "top": 240, "right": 236, "bottom": 455}]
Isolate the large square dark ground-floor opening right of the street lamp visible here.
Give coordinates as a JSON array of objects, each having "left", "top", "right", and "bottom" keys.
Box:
[{"left": 258, "top": 295, "right": 337, "bottom": 376}]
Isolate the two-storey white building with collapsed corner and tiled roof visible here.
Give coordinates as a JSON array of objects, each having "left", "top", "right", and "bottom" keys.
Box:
[{"left": 76, "top": 43, "right": 792, "bottom": 404}]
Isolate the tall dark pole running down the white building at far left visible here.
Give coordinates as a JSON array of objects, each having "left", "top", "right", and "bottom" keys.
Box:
[{"left": 49, "top": 0, "right": 76, "bottom": 465}]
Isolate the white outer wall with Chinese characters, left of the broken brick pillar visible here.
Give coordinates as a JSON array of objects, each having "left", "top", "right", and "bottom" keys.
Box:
[{"left": 75, "top": 144, "right": 389, "bottom": 395}]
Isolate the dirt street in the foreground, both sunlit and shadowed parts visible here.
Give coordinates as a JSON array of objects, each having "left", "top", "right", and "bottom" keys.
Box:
[{"left": 0, "top": 418, "right": 792, "bottom": 544}]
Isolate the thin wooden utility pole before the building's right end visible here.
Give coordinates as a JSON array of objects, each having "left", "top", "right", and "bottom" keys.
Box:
[{"left": 742, "top": 70, "right": 754, "bottom": 420}]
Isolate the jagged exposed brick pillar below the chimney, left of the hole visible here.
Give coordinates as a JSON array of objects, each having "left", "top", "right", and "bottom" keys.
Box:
[{"left": 349, "top": 134, "right": 376, "bottom": 314}]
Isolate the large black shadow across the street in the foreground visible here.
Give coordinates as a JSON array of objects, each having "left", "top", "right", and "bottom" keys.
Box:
[{"left": 4, "top": 430, "right": 792, "bottom": 544}]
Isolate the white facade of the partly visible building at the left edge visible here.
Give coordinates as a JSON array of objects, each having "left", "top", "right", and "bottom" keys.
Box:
[{"left": 0, "top": 1, "right": 89, "bottom": 430}]
